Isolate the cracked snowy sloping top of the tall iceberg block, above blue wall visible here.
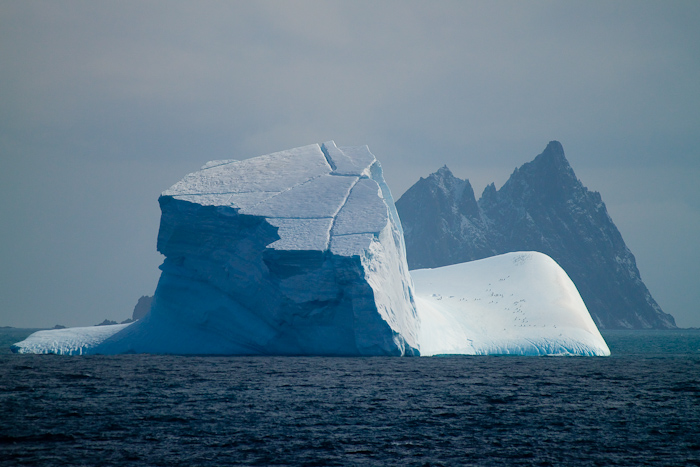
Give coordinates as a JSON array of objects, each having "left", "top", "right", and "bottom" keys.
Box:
[{"left": 162, "top": 141, "right": 401, "bottom": 256}]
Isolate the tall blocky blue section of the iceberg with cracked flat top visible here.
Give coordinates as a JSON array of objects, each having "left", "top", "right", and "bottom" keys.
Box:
[{"left": 15, "top": 141, "right": 419, "bottom": 355}]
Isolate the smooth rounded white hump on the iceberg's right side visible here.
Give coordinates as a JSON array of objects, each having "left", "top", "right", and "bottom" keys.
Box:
[{"left": 411, "top": 251, "right": 610, "bottom": 356}]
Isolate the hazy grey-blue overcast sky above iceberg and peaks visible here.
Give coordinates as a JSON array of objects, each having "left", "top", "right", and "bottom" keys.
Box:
[{"left": 0, "top": 0, "right": 700, "bottom": 327}]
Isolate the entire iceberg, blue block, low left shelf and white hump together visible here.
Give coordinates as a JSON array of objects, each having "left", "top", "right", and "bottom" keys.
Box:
[{"left": 12, "top": 141, "right": 609, "bottom": 356}]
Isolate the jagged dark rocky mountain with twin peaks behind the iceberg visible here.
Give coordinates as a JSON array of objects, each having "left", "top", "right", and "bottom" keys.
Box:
[{"left": 396, "top": 141, "right": 676, "bottom": 329}]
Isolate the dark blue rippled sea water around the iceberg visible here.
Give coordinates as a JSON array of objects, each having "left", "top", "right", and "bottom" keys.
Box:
[{"left": 0, "top": 330, "right": 700, "bottom": 466}]
